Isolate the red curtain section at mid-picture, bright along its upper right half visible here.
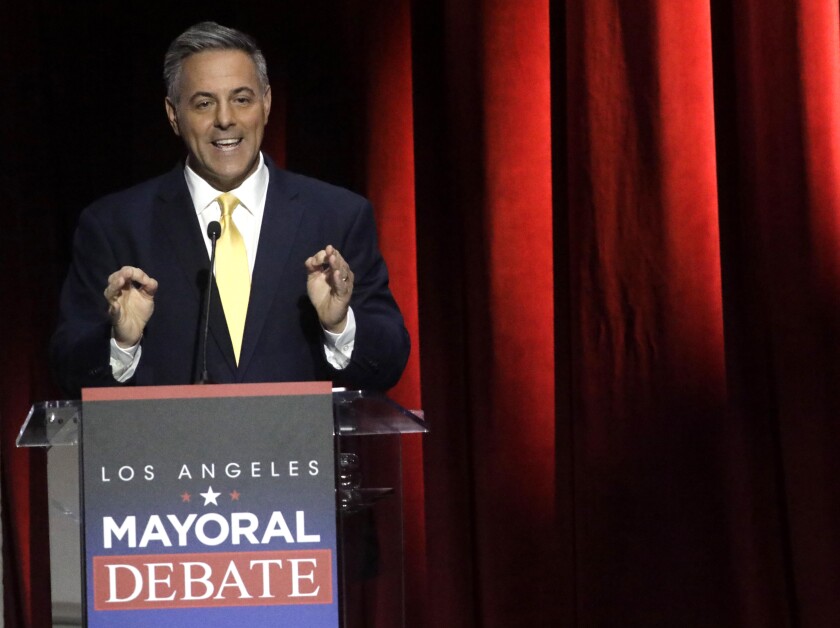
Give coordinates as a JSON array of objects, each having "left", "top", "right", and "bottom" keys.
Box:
[{"left": 413, "top": 1, "right": 568, "bottom": 626}]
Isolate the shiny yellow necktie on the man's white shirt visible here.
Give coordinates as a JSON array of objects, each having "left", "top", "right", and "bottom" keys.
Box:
[{"left": 216, "top": 192, "right": 251, "bottom": 365}]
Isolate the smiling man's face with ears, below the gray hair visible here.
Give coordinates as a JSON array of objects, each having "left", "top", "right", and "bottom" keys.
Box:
[{"left": 166, "top": 50, "right": 271, "bottom": 192}]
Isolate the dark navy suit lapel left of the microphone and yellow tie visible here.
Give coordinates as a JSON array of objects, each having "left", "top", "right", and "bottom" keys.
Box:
[{"left": 155, "top": 166, "right": 236, "bottom": 372}]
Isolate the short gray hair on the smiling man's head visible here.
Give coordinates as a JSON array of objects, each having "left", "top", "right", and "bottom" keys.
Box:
[{"left": 163, "top": 22, "right": 268, "bottom": 104}]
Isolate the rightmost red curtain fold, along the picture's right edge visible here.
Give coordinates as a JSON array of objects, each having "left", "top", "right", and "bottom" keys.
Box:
[{"left": 721, "top": 0, "right": 840, "bottom": 626}]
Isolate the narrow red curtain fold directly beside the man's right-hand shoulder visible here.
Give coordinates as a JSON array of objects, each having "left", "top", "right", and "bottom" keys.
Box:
[{"left": 354, "top": 0, "right": 428, "bottom": 623}]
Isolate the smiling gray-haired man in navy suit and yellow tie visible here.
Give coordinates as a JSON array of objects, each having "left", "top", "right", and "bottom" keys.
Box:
[{"left": 51, "top": 22, "right": 409, "bottom": 395}]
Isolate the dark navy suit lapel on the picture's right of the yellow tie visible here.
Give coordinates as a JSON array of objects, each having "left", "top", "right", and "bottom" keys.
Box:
[{"left": 239, "top": 164, "right": 305, "bottom": 373}]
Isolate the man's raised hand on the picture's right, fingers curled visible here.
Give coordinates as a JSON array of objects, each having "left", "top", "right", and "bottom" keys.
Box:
[{"left": 305, "top": 244, "right": 353, "bottom": 334}]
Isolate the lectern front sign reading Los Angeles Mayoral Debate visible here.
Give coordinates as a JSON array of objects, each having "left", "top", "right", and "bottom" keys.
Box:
[{"left": 82, "top": 383, "right": 338, "bottom": 628}]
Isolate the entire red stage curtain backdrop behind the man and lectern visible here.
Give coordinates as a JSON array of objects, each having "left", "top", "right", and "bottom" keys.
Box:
[{"left": 0, "top": 0, "right": 840, "bottom": 628}]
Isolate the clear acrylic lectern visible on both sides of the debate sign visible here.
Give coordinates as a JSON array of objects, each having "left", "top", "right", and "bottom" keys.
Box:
[{"left": 17, "top": 389, "right": 428, "bottom": 628}]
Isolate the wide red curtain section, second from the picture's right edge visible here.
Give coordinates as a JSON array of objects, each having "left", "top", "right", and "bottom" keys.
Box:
[{"left": 566, "top": 0, "right": 731, "bottom": 626}]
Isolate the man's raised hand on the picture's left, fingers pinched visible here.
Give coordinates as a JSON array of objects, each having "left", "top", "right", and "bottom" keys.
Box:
[{"left": 104, "top": 266, "right": 157, "bottom": 348}]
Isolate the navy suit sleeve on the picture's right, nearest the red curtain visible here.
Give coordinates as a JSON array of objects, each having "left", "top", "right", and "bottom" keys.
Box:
[{"left": 331, "top": 201, "right": 410, "bottom": 390}]
